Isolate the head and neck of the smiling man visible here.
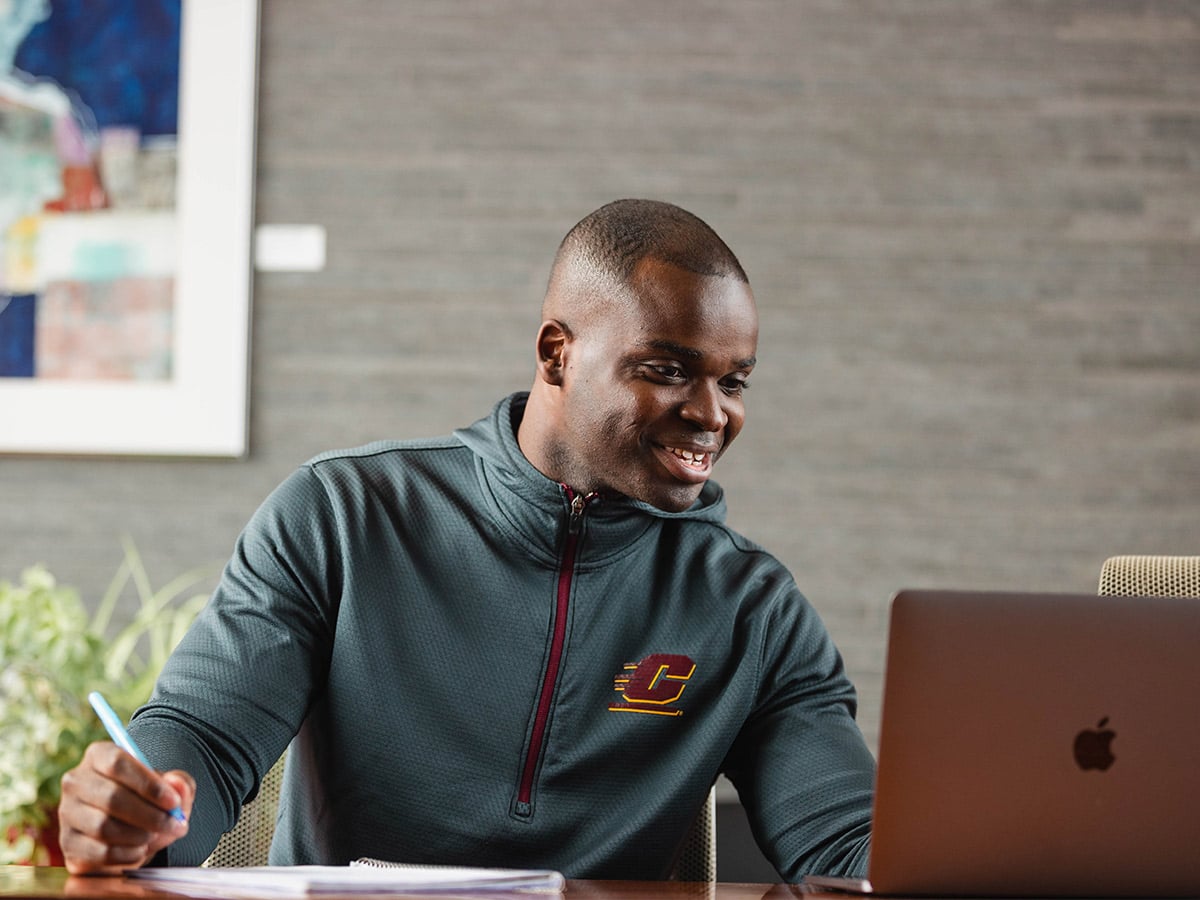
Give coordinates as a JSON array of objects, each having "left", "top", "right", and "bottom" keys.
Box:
[{"left": 520, "top": 200, "right": 758, "bottom": 511}]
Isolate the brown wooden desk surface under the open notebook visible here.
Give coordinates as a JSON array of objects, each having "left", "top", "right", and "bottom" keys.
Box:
[{"left": 0, "top": 865, "right": 806, "bottom": 900}]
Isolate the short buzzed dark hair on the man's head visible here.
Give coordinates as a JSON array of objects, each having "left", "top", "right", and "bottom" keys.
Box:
[{"left": 554, "top": 199, "right": 750, "bottom": 284}]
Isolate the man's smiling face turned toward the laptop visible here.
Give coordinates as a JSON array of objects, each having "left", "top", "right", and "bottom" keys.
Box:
[{"left": 553, "top": 259, "right": 758, "bottom": 511}]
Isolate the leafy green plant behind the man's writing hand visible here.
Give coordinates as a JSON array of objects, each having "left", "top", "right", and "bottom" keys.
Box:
[{"left": 0, "top": 540, "right": 215, "bottom": 864}]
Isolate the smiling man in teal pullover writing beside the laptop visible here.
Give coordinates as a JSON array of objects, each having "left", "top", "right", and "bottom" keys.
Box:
[{"left": 60, "top": 200, "right": 874, "bottom": 881}]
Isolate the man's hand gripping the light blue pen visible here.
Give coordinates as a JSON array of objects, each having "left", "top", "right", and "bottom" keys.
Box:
[{"left": 59, "top": 742, "right": 196, "bottom": 875}]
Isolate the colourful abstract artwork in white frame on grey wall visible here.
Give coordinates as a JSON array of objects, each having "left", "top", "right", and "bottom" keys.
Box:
[{"left": 0, "top": 0, "right": 258, "bottom": 456}]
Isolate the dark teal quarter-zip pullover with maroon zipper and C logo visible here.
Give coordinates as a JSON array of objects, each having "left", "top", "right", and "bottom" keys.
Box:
[{"left": 131, "top": 394, "right": 875, "bottom": 881}]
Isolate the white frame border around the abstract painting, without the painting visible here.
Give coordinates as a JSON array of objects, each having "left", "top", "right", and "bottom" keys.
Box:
[{"left": 0, "top": 0, "right": 259, "bottom": 457}]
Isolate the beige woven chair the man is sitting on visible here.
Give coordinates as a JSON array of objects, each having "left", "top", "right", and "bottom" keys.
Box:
[{"left": 203, "top": 754, "right": 716, "bottom": 881}]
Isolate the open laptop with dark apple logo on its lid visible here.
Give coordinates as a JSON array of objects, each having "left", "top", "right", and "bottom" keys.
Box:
[{"left": 805, "top": 590, "right": 1200, "bottom": 898}]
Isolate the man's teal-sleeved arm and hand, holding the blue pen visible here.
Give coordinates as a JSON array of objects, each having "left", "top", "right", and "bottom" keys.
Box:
[{"left": 62, "top": 467, "right": 341, "bottom": 871}]
